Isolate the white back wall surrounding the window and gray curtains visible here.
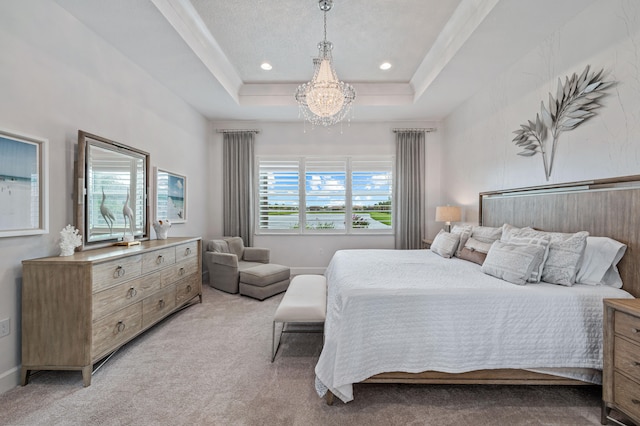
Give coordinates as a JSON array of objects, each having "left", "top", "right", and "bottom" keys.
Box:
[{"left": 207, "top": 122, "right": 441, "bottom": 273}]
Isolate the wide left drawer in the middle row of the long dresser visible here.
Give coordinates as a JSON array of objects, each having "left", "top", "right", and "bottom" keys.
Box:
[{"left": 93, "top": 272, "right": 161, "bottom": 321}]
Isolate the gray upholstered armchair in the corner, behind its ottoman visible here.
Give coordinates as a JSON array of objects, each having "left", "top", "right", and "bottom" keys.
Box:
[{"left": 204, "top": 237, "right": 270, "bottom": 293}]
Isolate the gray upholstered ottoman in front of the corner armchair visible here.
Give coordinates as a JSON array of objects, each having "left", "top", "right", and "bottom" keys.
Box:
[{"left": 239, "top": 263, "right": 291, "bottom": 300}]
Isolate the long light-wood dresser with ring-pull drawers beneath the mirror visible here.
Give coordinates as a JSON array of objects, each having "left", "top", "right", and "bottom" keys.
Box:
[{"left": 21, "top": 238, "right": 202, "bottom": 386}]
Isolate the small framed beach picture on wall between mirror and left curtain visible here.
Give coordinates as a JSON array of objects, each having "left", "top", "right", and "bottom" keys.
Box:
[{"left": 155, "top": 168, "right": 187, "bottom": 223}]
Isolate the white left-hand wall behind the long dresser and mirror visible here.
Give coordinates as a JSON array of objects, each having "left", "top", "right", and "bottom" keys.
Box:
[{"left": 0, "top": 0, "right": 208, "bottom": 393}]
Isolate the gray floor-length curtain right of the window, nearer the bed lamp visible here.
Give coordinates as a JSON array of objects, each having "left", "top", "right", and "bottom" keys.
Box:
[{"left": 394, "top": 131, "right": 426, "bottom": 249}]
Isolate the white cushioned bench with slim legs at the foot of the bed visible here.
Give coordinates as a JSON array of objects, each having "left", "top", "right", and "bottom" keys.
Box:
[{"left": 271, "top": 275, "right": 327, "bottom": 362}]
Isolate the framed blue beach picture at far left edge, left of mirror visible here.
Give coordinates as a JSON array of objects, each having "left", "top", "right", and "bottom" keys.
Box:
[{"left": 0, "top": 130, "right": 49, "bottom": 237}]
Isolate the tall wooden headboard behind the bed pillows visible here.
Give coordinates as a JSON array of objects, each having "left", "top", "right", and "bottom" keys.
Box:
[{"left": 479, "top": 175, "right": 640, "bottom": 297}]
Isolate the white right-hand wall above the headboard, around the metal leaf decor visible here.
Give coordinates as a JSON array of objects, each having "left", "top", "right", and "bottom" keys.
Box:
[{"left": 442, "top": 0, "right": 640, "bottom": 222}]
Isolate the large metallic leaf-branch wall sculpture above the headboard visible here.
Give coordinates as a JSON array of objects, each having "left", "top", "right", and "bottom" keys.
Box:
[{"left": 513, "top": 65, "right": 614, "bottom": 180}]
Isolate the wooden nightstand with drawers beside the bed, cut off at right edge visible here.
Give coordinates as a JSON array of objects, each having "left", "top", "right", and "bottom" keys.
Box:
[{"left": 602, "top": 299, "right": 640, "bottom": 424}]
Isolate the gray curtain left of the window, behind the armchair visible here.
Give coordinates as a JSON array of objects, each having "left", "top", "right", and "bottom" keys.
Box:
[{"left": 222, "top": 132, "right": 255, "bottom": 247}]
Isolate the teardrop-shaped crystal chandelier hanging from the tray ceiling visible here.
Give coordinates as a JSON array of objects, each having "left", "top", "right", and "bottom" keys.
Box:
[{"left": 296, "top": 0, "right": 356, "bottom": 127}]
